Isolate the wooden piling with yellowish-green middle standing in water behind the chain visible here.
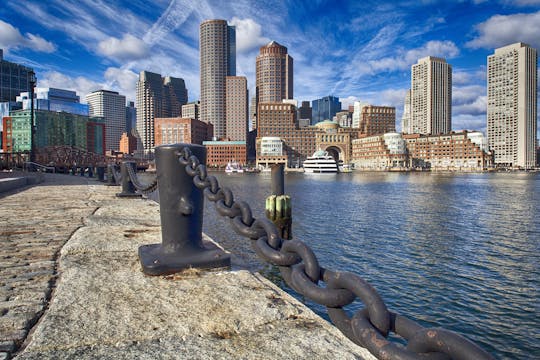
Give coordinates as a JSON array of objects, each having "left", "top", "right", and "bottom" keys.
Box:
[{"left": 266, "top": 164, "right": 292, "bottom": 240}]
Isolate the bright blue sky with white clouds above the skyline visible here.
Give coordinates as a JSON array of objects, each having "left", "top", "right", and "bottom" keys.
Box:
[{"left": 0, "top": 0, "right": 540, "bottom": 131}]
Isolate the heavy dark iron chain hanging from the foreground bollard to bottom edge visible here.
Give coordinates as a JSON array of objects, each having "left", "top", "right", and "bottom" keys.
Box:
[{"left": 176, "top": 147, "right": 493, "bottom": 360}]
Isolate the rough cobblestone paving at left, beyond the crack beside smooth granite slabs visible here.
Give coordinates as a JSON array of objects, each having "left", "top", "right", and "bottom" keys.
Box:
[{"left": 0, "top": 174, "right": 102, "bottom": 359}]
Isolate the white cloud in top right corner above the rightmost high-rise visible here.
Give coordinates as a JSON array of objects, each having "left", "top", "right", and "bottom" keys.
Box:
[{"left": 466, "top": 11, "right": 540, "bottom": 49}]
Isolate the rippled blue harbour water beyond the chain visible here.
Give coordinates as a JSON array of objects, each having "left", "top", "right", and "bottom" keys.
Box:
[{"left": 199, "top": 173, "right": 540, "bottom": 359}]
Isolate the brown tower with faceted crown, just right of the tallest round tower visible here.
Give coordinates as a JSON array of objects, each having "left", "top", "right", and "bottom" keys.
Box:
[{"left": 255, "top": 41, "right": 294, "bottom": 122}]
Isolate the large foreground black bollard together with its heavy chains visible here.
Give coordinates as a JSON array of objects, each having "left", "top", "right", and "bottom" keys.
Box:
[{"left": 122, "top": 144, "right": 493, "bottom": 360}]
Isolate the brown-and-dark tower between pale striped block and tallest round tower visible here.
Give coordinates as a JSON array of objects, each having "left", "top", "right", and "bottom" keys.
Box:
[{"left": 136, "top": 71, "right": 187, "bottom": 152}]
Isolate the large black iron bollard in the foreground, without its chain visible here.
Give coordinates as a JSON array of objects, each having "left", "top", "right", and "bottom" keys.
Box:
[{"left": 139, "top": 144, "right": 231, "bottom": 275}]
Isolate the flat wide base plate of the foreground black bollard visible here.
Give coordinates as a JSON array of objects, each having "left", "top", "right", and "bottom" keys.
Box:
[{"left": 139, "top": 244, "right": 231, "bottom": 276}]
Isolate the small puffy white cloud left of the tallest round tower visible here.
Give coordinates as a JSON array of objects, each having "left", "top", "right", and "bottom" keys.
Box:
[{"left": 98, "top": 34, "right": 149, "bottom": 61}]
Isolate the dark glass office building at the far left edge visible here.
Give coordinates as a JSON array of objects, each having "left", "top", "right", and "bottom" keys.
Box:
[{"left": 0, "top": 49, "right": 33, "bottom": 102}]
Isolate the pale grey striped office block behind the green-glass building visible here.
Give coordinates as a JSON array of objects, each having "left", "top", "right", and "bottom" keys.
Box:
[{"left": 86, "top": 90, "right": 126, "bottom": 151}]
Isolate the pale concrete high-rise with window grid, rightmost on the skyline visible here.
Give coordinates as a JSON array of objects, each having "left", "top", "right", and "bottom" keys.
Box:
[{"left": 487, "top": 43, "right": 538, "bottom": 168}]
